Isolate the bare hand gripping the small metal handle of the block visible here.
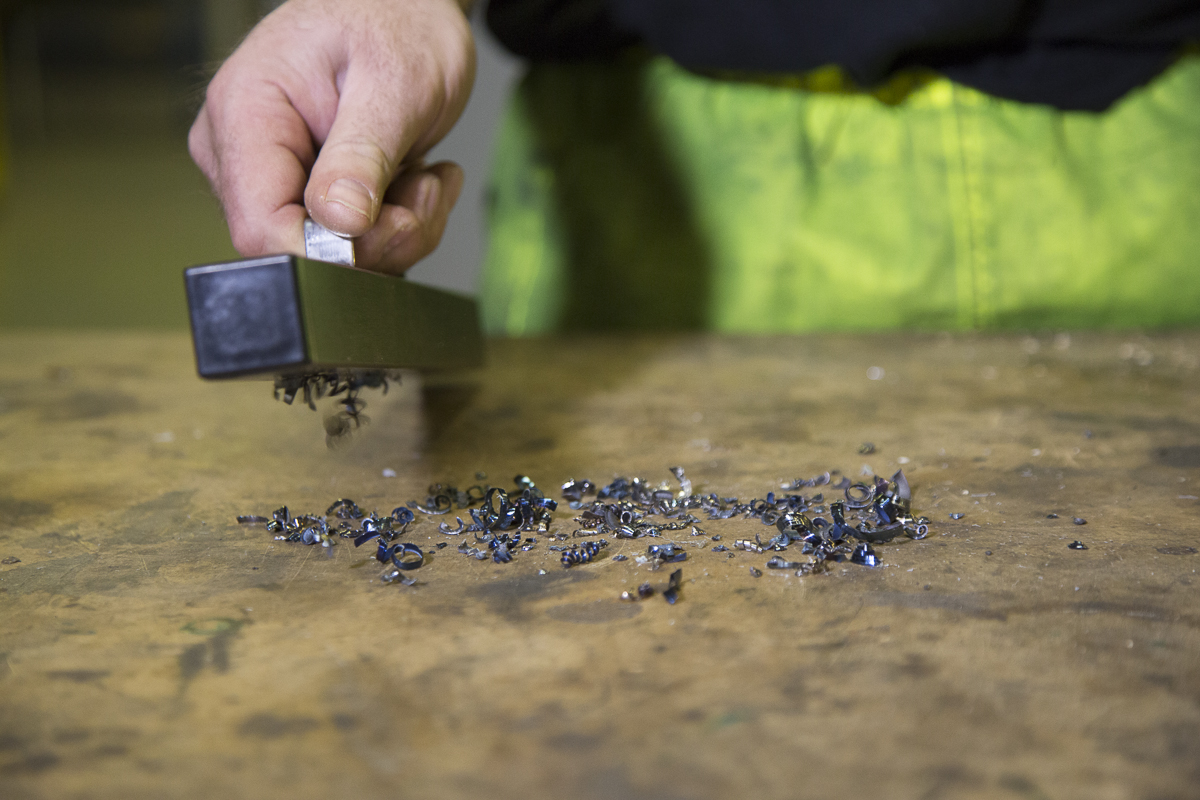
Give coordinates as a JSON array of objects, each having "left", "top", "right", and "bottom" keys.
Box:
[{"left": 187, "top": 0, "right": 475, "bottom": 273}]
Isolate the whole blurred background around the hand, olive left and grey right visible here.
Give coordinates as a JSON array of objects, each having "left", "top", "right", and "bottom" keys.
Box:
[{"left": 0, "top": 0, "right": 521, "bottom": 329}]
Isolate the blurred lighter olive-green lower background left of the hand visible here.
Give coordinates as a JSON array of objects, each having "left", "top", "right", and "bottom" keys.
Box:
[{"left": 0, "top": 134, "right": 236, "bottom": 329}]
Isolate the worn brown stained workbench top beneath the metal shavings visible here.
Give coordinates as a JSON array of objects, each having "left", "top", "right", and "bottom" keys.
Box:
[{"left": 0, "top": 333, "right": 1200, "bottom": 800}]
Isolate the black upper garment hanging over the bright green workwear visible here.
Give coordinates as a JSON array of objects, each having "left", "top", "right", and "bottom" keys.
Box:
[{"left": 488, "top": 0, "right": 1200, "bottom": 110}]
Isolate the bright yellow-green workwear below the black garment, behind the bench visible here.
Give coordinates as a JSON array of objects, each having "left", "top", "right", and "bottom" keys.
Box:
[{"left": 482, "top": 54, "right": 1200, "bottom": 335}]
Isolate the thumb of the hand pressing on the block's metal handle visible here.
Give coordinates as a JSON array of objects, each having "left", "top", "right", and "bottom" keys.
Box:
[{"left": 305, "top": 72, "right": 429, "bottom": 236}]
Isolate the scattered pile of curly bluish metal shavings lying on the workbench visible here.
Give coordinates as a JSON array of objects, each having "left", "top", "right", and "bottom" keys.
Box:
[{"left": 231, "top": 467, "right": 929, "bottom": 603}]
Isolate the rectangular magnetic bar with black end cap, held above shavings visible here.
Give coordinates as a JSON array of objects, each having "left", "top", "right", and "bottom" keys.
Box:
[{"left": 184, "top": 255, "right": 484, "bottom": 378}]
